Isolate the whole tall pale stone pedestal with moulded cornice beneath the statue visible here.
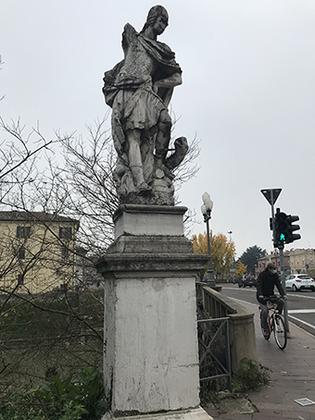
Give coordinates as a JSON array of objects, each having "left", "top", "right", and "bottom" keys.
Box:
[{"left": 98, "top": 205, "right": 214, "bottom": 419}]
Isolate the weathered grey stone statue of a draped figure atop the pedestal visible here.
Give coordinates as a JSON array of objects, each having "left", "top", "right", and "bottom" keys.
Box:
[{"left": 103, "top": 6, "right": 188, "bottom": 205}]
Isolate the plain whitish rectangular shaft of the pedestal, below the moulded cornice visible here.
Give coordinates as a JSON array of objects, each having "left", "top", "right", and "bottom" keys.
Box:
[{"left": 105, "top": 275, "right": 199, "bottom": 413}]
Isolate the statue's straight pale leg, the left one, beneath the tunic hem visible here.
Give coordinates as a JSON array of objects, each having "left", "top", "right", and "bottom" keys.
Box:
[{"left": 127, "top": 130, "right": 150, "bottom": 190}]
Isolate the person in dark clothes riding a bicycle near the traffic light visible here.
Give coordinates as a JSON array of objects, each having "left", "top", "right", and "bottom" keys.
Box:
[{"left": 256, "top": 263, "right": 285, "bottom": 336}]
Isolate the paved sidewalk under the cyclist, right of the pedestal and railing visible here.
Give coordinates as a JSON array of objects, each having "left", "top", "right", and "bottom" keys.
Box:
[{"left": 209, "top": 302, "right": 315, "bottom": 420}]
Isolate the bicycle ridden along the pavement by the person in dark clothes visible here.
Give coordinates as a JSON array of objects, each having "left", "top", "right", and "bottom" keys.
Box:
[{"left": 259, "top": 296, "right": 288, "bottom": 350}]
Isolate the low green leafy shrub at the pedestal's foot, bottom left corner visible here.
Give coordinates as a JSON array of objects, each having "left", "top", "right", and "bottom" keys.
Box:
[{"left": 0, "top": 368, "right": 106, "bottom": 420}]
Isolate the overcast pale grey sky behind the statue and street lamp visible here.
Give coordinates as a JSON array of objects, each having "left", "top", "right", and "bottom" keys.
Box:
[{"left": 0, "top": 0, "right": 315, "bottom": 254}]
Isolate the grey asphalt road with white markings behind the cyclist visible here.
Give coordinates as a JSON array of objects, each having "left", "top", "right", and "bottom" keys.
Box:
[{"left": 221, "top": 284, "right": 315, "bottom": 335}]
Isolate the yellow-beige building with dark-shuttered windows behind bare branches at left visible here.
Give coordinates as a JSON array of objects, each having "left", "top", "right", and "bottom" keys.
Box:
[{"left": 0, "top": 211, "right": 79, "bottom": 293}]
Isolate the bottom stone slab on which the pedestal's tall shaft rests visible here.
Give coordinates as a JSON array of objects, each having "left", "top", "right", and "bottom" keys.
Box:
[{"left": 102, "top": 407, "right": 213, "bottom": 420}]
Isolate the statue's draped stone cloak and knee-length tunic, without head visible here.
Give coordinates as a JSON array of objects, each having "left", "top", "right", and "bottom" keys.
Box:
[{"left": 103, "top": 24, "right": 181, "bottom": 186}]
